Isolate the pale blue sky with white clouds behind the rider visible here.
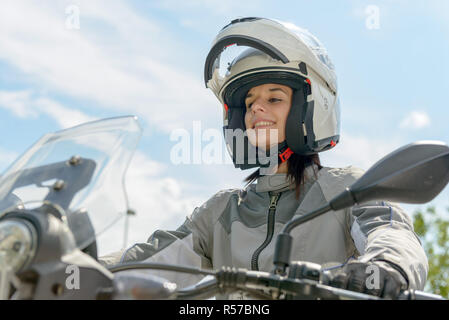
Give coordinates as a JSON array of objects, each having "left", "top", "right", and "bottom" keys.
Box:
[{"left": 0, "top": 0, "right": 449, "bottom": 255}]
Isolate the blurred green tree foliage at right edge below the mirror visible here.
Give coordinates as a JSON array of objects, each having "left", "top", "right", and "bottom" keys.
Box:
[{"left": 413, "top": 206, "right": 449, "bottom": 298}]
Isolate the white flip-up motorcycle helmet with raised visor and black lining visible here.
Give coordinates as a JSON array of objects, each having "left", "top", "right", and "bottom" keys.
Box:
[{"left": 204, "top": 17, "right": 340, "bottom": 169}]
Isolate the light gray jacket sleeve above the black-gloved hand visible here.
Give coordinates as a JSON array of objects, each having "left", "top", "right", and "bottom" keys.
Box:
[{"left": 348, "top": 201, "right": 428, "bottom": 290}]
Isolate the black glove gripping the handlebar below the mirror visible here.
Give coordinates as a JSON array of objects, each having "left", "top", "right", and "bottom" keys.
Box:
[{"left": 329, "top": 261, "right": 408, "bottom": 299}]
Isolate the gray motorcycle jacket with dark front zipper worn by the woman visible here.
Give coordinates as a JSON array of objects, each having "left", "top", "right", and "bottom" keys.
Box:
[{"left": 100, "top": 166, "right": 428, "bottom": 290}]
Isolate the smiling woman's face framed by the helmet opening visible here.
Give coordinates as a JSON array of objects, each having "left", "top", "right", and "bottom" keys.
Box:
[{"left": 245, "top": 83, "right": 293, "bottom": 150}]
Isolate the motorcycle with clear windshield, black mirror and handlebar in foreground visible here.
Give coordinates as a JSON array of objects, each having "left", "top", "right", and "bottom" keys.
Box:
[{"left": 0, "top": 116, "right": 449, "bottom": 300}]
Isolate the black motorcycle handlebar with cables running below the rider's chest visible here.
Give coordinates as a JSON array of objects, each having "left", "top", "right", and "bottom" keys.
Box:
[{"left": 109, "top": 263, "right": 446, "bottom": 300}]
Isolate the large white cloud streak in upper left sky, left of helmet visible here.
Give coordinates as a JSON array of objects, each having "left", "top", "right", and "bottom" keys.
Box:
[{"left": 0, "top": 1, "right": 219, "bottom": 131}]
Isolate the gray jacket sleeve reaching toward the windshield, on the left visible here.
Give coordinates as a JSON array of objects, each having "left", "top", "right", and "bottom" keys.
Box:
[{"left": 99, "top": 199, "right": 212, "bottom": 287}]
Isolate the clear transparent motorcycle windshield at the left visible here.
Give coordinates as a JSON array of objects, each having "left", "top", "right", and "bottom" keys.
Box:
[{"left": 0, "top": 116, "right": 142, "bottom": 249}]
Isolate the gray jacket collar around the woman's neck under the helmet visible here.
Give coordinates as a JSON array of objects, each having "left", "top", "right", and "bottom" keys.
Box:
[{"left": 256, "top": 164, "right": 318, "bottom": 192}]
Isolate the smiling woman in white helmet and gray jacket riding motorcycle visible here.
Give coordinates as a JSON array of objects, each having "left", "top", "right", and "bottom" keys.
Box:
[{"left": 102, "top": 18, "right": 428, "bottom": 297}]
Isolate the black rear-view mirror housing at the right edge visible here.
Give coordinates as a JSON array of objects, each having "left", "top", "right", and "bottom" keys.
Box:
[{"left": 329, "top": 141, "right": 449, "bottom": 210}]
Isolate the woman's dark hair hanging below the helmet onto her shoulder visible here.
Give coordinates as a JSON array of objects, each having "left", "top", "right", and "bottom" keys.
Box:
[{"left": 244, "top": 153, "right": 323, "bottom": 199}]
